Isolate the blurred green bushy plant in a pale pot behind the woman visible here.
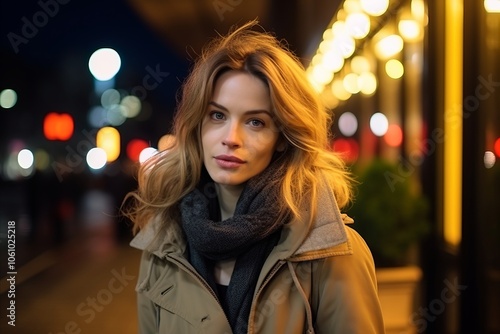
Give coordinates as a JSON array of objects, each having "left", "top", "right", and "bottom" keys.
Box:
[{"left": 347, "top": 160, "right": 430, "bottom": 333}]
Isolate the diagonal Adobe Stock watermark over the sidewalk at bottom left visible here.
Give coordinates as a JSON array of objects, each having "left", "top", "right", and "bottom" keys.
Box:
[{"left": 49, "top": 267, "right": 136, "bottom": 334}]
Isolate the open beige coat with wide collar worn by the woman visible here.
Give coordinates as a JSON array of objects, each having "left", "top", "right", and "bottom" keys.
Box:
[{"left": 131, "top": 187, "right": 384, "bottom": 334}]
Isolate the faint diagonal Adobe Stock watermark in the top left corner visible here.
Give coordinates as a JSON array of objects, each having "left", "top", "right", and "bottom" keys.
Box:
[{"left": 7, "top": 0, "right": 71, "bottom": 54}]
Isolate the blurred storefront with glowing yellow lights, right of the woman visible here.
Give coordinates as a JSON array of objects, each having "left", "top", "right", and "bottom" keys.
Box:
[{"left": 308, "top": 0, "right": 500, "bottom": 333}]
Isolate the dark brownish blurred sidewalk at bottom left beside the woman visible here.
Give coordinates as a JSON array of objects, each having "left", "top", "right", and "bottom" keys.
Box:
[{"left": 0, "top": 239, "right": 140, "bottom": 334}]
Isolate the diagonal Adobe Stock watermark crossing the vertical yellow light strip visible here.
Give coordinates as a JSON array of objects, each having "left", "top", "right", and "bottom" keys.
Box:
[{"left": 385, "top": 74, "right": 500, "bottom": 191}]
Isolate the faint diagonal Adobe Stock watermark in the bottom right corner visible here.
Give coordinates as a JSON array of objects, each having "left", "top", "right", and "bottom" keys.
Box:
[{"left": 408, "top": 277, "right": 467, "bottom": 333}]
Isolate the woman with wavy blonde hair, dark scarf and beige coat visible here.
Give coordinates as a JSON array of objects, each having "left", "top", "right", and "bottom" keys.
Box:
[{"left": 124, "top": 22, "right": 384, "bottom": 334}]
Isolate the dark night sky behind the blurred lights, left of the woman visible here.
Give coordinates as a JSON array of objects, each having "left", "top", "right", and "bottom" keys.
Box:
[{"left": 0, "top": 0, "right": 190, "bottom": 154}]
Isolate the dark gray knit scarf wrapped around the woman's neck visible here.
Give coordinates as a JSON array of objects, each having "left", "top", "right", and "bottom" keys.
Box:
[{"left": 180, "top": 158, "right": 287, "bottom": 333}]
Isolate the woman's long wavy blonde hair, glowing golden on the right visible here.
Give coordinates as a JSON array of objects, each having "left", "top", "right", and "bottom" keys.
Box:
[{"left": 126, "top": 21, "right": 352, "bottom": 232}]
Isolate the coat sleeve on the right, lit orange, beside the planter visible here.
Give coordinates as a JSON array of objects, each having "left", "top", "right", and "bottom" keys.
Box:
[{"left": 313, "top": 226, "right": 385, "bottom": 334}]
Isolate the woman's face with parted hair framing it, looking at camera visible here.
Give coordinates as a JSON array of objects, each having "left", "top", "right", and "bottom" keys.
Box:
[{"left": 201, "top": 71, "right": 279, "bottom": 186}]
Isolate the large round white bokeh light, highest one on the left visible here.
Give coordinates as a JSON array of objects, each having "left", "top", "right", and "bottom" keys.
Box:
[{"left": 89, "top": 48, "right": 122, "bottom": 81}]
